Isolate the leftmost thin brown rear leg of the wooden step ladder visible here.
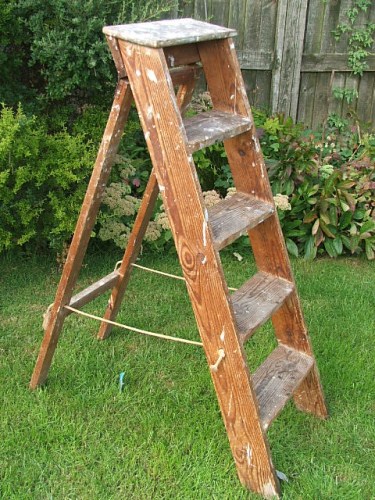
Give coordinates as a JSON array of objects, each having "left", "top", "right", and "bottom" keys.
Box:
[{"left": 30, "top": 80, "right": 133, "bottom": 389}]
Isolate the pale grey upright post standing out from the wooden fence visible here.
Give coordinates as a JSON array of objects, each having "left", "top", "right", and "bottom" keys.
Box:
[{"left": 271, "top": 0, "right": 308, "bottom": 120}]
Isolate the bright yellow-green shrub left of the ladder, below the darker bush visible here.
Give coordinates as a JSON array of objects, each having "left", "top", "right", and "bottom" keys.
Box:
[{"left": 0, "top": 107, "right": 95, "bottom": 251}]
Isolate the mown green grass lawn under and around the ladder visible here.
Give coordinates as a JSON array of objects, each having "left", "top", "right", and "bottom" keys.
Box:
[{"left": 0, "top": 248, "right": 375, "bottom": 500}]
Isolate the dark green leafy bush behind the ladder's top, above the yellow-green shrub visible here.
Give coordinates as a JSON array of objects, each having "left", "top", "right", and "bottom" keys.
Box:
[{"left": 0, "top": 0, "right": 175, "bottom": 106}]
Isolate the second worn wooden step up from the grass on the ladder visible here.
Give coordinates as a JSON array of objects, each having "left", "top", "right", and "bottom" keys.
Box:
[{"left": 231, "top": 272, "right": 294, "bottom": 342}]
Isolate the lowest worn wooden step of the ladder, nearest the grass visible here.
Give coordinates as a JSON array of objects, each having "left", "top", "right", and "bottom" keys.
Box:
[{"left": 252, "top": 345, "right": 314, "bottom": 430}]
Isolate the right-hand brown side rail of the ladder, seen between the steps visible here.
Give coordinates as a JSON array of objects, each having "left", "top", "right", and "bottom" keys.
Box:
[{"left": 199, "top": 39, "right": 327, "bottom": 418}]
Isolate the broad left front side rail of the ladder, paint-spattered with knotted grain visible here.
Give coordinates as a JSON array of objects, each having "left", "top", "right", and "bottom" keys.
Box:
[{"left": 119, "top": 40, "right": 279, "bottom": 497}]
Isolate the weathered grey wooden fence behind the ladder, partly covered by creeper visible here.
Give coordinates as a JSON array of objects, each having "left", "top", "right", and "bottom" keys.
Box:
[{"left": 173, "top": 0, "right": 375, "bottom": 127}]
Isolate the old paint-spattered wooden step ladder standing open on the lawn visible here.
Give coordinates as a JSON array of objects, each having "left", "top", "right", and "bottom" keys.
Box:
[{"left": 30, "top": 19, "right": 327, "bottom": 498}]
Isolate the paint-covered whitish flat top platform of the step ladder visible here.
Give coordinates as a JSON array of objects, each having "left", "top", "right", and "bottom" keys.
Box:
[{"left": 103, "top": 18, "right": 237, "bottom": 47}]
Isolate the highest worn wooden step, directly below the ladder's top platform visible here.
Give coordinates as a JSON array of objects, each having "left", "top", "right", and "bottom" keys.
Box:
[{"left": 184, "top": 110, "right": 252, "bottom": 154}]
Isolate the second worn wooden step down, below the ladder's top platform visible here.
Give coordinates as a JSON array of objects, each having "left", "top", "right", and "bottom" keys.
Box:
[{"left": 208, "top": 193, "right": 274, "bottom": 250}]
